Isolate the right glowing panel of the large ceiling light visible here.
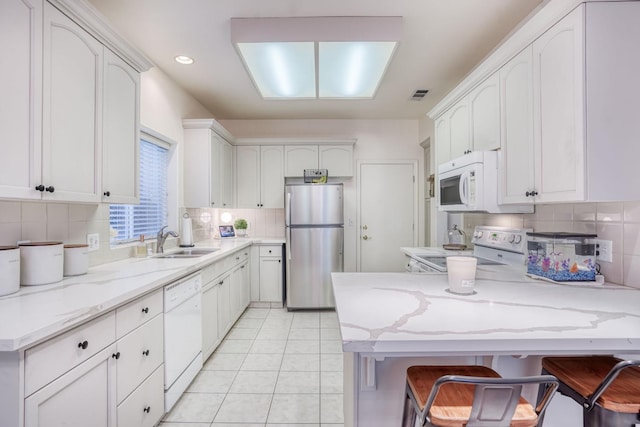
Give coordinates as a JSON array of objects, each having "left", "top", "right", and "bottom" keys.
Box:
[{"left": 318, "top": 42, "right": 396, "bottom": 98}]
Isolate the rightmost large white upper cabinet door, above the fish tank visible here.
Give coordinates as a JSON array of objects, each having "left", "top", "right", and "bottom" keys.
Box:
[{"left": 533, "top": 4, "right": 585, "bottom": 202}]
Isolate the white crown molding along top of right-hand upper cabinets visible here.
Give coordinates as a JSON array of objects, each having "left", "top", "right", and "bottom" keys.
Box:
[{"left": 427, "top": 0, "right": 591, "bottom": 119}]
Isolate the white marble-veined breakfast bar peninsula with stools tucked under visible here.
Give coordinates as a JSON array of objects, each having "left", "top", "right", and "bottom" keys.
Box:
[{"left": 332, "top": 266, "right": 640, "bottom": 427}]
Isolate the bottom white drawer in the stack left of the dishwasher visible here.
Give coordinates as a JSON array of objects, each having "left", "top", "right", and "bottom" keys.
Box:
[{"left": 118, "top": 365, "right": 164, "bottom": 427}]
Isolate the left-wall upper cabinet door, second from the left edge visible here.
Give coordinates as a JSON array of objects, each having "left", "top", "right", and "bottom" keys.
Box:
[{"left": 42, "top": 3, "right": 102, "bottom": 203}]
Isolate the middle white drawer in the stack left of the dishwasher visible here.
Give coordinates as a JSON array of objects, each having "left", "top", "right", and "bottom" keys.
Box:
[{"left": 116, "top": 315, "right": 164, "bottom": 402}]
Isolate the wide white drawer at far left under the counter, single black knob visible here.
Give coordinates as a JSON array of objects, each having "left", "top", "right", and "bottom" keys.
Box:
[{"left": 24, "top": 311, "right": 116, "bottom": 396}]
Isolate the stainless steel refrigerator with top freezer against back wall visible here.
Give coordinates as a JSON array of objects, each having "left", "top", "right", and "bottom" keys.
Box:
[{"left": 285, "top": 184, "right": 344, "bottom": 310}]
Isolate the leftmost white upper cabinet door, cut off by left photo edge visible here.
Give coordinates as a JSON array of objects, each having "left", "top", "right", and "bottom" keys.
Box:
[{"left": 0, "top": 0, "right": 42, "bottom": 199}]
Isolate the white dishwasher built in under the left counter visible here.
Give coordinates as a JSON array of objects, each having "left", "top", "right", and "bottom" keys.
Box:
[{"left": 164, "top": 272, "right": 202, "bottom": 412}]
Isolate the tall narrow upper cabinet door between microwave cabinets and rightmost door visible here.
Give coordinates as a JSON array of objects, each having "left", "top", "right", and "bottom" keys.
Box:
[{"left": 500, "top": 46, "right": 535, "bottom": 204}]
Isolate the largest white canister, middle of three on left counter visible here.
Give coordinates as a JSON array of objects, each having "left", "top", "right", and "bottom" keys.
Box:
[{"left": 20, "top": 242, "right": 64, "bottom": 286}]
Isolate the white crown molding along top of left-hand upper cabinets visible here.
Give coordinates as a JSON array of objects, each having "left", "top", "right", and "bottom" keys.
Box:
[{"left": 47, "top": 0, "right": 154, "bottom": 72}]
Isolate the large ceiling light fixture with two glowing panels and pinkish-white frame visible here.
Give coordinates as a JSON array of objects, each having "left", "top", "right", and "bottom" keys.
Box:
[{"left": 231, "top": 16, "right": 402, "bottom": 99}]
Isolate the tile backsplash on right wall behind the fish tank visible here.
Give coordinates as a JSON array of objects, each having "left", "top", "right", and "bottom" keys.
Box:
[{"left": 464, "top": 201, "right": 640, "bottom": 288}]
